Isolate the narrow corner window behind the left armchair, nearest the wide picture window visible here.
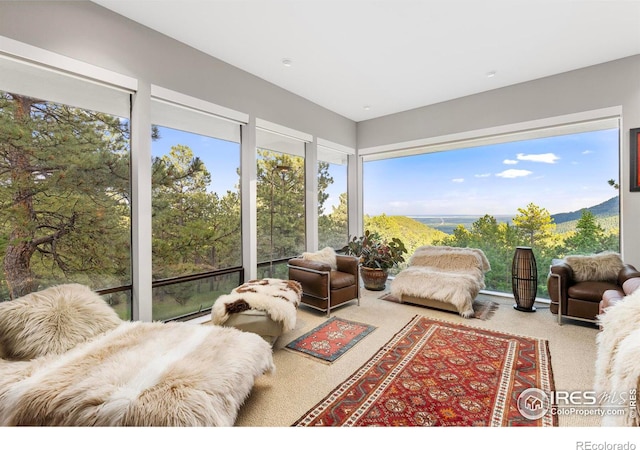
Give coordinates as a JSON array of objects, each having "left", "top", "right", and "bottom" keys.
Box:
[{"left": 318, "top": 146, "right": 349, "bottom": 250}]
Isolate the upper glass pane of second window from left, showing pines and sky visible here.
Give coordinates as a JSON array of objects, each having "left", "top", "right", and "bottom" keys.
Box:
[{"left": 152, "top": 127, "right": 242, "bottom": 280}]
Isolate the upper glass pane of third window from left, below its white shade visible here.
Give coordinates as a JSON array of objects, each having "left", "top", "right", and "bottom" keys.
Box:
[{"left": 257, "top": 149, "right": 305, "bottom": 272}]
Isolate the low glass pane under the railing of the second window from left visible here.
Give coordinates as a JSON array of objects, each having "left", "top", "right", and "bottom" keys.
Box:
[{"left": 153, "top": 272, "right": 241, "bottom": 321}]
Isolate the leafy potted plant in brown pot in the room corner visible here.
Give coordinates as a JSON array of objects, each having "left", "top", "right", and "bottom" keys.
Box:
[{"left": 346, "top": 230, "right": 407, "bottom": 291}]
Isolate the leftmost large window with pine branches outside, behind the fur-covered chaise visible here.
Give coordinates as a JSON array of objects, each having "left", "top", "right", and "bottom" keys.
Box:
[{"left": 0, "top": 57, "right": 131, "bottom": 319}]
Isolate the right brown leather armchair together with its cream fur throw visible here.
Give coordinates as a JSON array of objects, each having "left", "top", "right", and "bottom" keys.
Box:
[{"left": 547, "top": 252, "right": 640, "bottom": 324}]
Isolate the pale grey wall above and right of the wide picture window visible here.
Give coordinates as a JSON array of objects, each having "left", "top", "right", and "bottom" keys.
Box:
[{"left": 357, "top": 55, "right": 640, "bottom": 268}]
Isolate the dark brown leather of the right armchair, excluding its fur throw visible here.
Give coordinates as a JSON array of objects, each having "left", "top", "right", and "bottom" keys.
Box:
[{"left": 547, "top": 260, "right": 640, "bottom": 324}]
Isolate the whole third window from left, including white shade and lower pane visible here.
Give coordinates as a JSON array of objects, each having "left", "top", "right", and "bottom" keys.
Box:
[{"left": 257, "top": 130, "right": 306, "bottom": 278}]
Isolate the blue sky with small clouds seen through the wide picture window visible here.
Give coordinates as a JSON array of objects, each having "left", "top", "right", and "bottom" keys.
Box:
[{"left": 363, "top": 129, "right": 619, "bottom": 216}]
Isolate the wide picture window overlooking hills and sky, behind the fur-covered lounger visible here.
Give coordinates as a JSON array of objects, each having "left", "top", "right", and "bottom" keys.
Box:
[{"left": 363, "top": 123, "right": 620, "bottom": 297}]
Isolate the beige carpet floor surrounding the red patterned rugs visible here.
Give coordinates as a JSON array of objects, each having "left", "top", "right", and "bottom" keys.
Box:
[{"left": 236, "top": 289, "right": 600, "bottom": 427}]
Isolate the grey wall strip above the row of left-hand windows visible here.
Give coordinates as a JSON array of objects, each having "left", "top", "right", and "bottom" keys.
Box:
[{"left": 0, "top": 1, "right": 356, "bottom": 148}]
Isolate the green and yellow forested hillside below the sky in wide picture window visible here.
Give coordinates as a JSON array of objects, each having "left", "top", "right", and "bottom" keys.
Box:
[{"left": 365, "top": 197, "right": 619, "bottom": 297}]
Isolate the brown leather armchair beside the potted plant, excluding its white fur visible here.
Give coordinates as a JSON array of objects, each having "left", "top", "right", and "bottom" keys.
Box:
[{"left": 287, "top": 255, "right": 360, "bottom": 316}]
